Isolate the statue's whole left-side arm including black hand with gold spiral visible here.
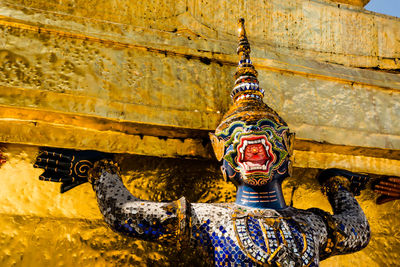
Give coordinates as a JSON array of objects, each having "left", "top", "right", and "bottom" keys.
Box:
[{"left": 34, "top": 148, "right": 188, "bottom": 247}]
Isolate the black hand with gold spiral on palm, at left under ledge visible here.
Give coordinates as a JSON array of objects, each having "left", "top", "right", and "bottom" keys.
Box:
[{"left": 33, "top": 148, "right": 112, "bottom": 193}]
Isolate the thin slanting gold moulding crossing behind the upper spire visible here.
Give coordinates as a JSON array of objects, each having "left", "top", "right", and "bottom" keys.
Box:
[{"left": 0, "top": 16, "right": 400, "bottom": 90}]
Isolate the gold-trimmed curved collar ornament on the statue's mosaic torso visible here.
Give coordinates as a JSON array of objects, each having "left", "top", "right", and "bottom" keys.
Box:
[{"left": 232, "top": 213, "right": 315, "bottom": 267}]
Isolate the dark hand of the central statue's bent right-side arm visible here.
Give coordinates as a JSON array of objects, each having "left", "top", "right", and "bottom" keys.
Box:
[{"left": 318, "top": 168, "right": 369, "bottom": 196}]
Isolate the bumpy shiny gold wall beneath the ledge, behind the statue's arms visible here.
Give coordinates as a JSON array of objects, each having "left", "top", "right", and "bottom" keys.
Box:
[{"left": 0, "top": 145, "right": 400, "bottom": 267}]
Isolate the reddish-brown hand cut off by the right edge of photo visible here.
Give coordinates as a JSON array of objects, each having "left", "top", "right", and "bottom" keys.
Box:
[{"left": 372, "top": 177, "right": 400, "bottom": 205}]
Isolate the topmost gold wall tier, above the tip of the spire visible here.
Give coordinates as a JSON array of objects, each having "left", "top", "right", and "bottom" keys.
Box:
[{"left": 0, "top": 0, "right": 400, "bottom": 70}]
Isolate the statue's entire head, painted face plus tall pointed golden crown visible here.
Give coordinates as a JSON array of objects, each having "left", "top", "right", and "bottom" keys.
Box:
[{"left": 210, "top": 19, "right": 294, "bottom": 187}]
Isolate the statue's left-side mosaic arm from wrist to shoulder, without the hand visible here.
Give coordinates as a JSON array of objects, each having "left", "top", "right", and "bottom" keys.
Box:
[{"left": 89, "top": 160, "right": 188, "bottom": 245}]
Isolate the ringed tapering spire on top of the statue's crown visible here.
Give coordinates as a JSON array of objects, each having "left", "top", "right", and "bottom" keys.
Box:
[{"left": 231, "top": 18, "right": 264, "bottom": 102}]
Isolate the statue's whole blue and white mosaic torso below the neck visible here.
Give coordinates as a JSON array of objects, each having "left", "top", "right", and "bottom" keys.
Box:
[{"left": 192, "top": 207, "right": 318, "bottom": 267}]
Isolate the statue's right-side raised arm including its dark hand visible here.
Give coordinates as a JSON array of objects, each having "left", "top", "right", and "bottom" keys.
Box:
[{"left": 314, "top": 169, "right": 370, "bottom": 259}]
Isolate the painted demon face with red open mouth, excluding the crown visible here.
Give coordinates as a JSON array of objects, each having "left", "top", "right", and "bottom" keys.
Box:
[{"left": 210, "top": 103, "right": 294, "bottom": 189}]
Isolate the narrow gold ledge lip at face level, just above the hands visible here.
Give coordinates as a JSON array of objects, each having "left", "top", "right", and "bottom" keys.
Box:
[{"left": 0, "top": 109, "right": 400, "bottom": 175}]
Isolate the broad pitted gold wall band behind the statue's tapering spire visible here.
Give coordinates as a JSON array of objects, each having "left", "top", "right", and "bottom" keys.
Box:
[{"left": 0, "top": 23, "right": 400, "bottom": 149}]
